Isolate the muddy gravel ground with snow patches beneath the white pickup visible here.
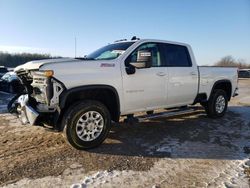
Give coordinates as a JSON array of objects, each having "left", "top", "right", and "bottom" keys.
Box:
[{"left": 0, "top": 79, "right": 250, "bottom": 188}]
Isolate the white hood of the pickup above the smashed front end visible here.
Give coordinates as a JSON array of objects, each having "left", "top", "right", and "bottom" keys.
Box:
[{"left": 14, "top": 58, "right": 79, "bottom": 72}]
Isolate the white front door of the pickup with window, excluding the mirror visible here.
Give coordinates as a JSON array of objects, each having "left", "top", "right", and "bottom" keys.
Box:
[{"left": 122, "top": 43, "right": 168, "bottom": 113}]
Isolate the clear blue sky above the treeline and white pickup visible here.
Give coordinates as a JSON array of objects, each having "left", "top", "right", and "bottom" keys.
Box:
[{"left": 0, "top": 0, "right": 250, "bottom": 65}]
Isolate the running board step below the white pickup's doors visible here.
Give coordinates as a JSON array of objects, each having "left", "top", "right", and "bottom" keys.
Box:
[{"left": 125, "top": 108, "right": 196, "bottom": 123}]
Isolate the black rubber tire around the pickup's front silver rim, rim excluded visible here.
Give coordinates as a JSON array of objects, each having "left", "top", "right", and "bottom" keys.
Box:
[{"left": 62, "top": 100, "right": 111, "bottom": 150}]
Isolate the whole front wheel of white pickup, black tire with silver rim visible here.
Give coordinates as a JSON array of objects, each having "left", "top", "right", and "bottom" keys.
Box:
[{"left": 64, "top": 100, "right": 111, "bottom": 150}]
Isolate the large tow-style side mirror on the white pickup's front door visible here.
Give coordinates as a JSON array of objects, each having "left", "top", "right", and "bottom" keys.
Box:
[{"left": 130, "top": 50, "right": 152, "bottom": 69}]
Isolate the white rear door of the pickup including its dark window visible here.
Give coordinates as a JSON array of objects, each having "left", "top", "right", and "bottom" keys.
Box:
[{"left": 163, "top": 43, "right": 198, "bottom": 107}]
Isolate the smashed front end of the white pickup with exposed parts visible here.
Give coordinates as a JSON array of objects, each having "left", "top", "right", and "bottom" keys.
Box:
[{"left": 8, "top": 70, "right": 65, "bottom": 125}]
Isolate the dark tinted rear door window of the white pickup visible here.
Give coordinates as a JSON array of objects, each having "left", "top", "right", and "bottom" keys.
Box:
[{"left": 164, "top": 44, "right": 192, "bottom": 67}]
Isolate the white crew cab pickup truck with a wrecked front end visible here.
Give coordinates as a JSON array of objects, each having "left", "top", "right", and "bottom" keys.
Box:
[{"left": 9, "top": 39, "right": 238, "bottom": 149}]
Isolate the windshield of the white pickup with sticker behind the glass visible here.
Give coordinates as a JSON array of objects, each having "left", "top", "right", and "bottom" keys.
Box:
[{"left": 84, "top": 42, "right": 134, "bottom": 60}]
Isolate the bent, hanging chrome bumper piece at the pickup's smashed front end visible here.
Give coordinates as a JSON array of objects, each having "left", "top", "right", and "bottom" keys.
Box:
[{"left": 17, "top": 94, "right": 39, "bottom": 125}]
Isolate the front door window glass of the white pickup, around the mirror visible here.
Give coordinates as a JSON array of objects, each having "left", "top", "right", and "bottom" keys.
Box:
[{"left": 126, "top": 43, "right": 162, "bottom": 67}]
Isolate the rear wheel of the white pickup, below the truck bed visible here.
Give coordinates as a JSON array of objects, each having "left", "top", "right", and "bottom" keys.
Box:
[{"left": 201, "top": 89, "right": 228, "bottom": 118}]
